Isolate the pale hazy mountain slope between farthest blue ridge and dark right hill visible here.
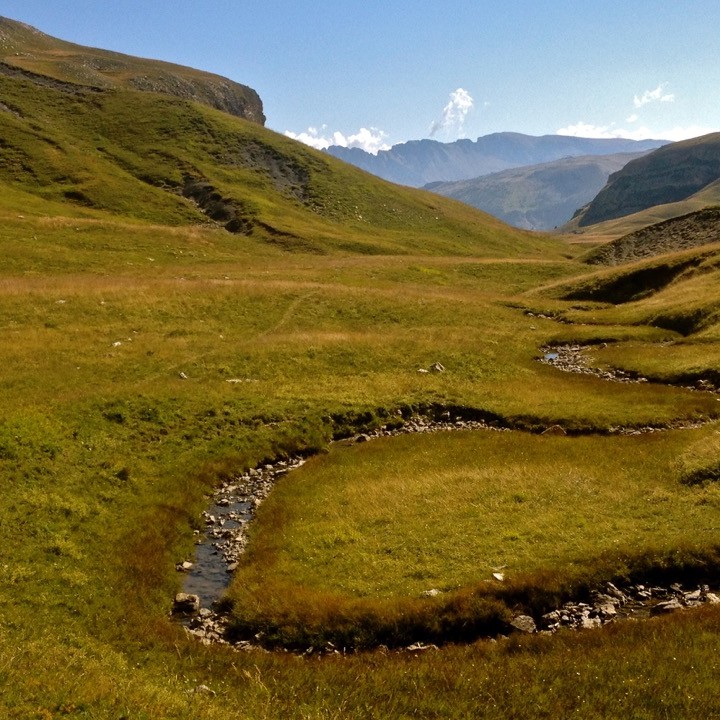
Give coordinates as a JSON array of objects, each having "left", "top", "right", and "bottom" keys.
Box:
[{"left": 425, "top": 153, "right": 642, "bottom": 230}]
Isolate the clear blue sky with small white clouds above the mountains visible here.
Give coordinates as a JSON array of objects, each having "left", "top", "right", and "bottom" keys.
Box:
[{"left": 0, "top": 0, "right": 720, "bottom": 150}]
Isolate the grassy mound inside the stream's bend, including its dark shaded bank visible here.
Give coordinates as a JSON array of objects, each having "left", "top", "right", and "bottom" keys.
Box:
[{"left": 230, "top": 426, "right": 720, "bottom": 647}]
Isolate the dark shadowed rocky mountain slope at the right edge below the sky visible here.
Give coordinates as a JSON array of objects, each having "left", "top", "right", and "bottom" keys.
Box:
[{"left": 578, "top": 133, "right": 720, "bottom": 227}]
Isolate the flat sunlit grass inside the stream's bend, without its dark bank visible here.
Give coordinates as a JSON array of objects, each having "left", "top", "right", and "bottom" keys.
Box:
[{"left": 237, "top": 429, "right": 720, "bottom": 597}]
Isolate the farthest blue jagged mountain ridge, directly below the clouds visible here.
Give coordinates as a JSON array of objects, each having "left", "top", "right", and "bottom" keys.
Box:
[{"left": 326, "top": 132, "right": 665, "bottom": 187}]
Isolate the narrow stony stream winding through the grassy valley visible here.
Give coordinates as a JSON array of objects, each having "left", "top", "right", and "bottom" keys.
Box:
[{"left": 175, "top": 345, "right": 720, "bottom": 647}]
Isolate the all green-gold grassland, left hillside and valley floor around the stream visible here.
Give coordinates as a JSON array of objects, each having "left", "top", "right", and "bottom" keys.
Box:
[{"left": 0, "top": 12, "right": 720, "bottom": 720}]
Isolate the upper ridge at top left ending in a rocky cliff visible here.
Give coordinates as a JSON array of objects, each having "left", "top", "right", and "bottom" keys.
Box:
[{"left": 0, "top": 17, "right": 265, "bottom": 125}]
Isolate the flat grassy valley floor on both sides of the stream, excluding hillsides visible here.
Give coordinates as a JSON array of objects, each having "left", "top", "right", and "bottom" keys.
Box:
[{"left": 0, "top": 219, "right": 718, "bottom": 718}]
